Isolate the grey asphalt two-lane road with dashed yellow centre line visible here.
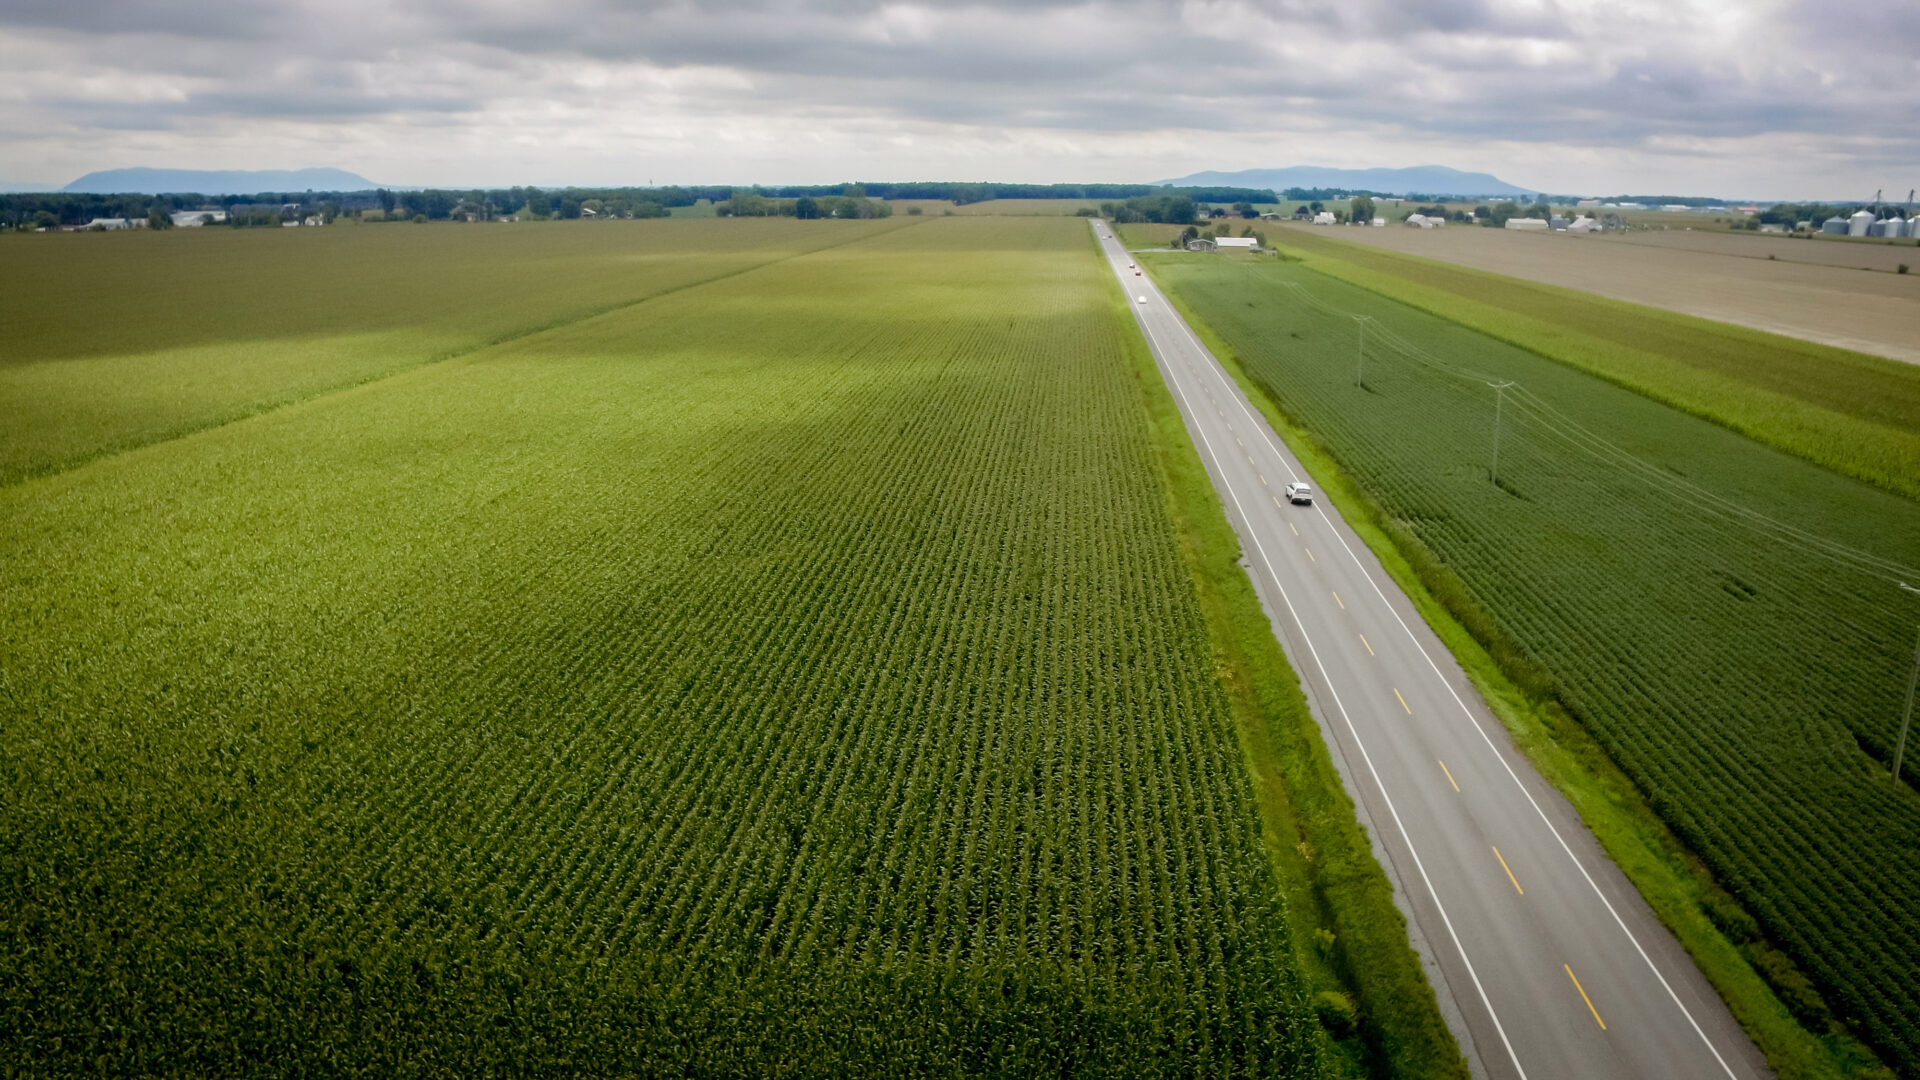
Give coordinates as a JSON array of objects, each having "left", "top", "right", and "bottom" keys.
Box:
[{"left": 1094, "top": 221, "right": 1768, "bottom": 1080}]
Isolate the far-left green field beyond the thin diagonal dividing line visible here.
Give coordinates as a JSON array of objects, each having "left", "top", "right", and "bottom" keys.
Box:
[{"left": 0, "top": 219, "right": 897, "bottom": 484}]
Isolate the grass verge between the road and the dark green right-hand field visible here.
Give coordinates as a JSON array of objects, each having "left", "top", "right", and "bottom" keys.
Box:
[{"left": 1167, "top": 270, "right": 1893, "bottom": 1080}]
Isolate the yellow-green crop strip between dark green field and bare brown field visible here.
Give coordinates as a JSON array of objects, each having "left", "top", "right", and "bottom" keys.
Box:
[{"left": 1275, "top": 229, "right": 1920, "bottom": 498}]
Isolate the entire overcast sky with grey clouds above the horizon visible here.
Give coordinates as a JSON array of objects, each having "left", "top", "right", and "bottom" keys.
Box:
[{"left": 0, "top": 0, "right": 1920, "bottom": 198}]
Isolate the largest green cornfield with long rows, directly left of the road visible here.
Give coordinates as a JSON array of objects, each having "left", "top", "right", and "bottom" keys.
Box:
[{"left": 0, "top": 219, "right": 1327, "bottom": 1078}]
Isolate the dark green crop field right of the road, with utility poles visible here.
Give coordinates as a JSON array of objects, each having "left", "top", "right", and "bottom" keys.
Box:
[{"left": 1148, "top": 254, "right": 1920, "bottom": 1072}]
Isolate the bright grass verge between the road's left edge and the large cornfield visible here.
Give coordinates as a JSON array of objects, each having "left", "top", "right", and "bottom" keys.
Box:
[{"left": 1089, "top": 238, "right": 1467, "bottom": 1078}]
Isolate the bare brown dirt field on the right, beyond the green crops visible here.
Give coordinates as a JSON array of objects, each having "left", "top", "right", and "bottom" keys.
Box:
[{"left": 1279, "top": 225, "right": 1920, "bottom": 363}]
